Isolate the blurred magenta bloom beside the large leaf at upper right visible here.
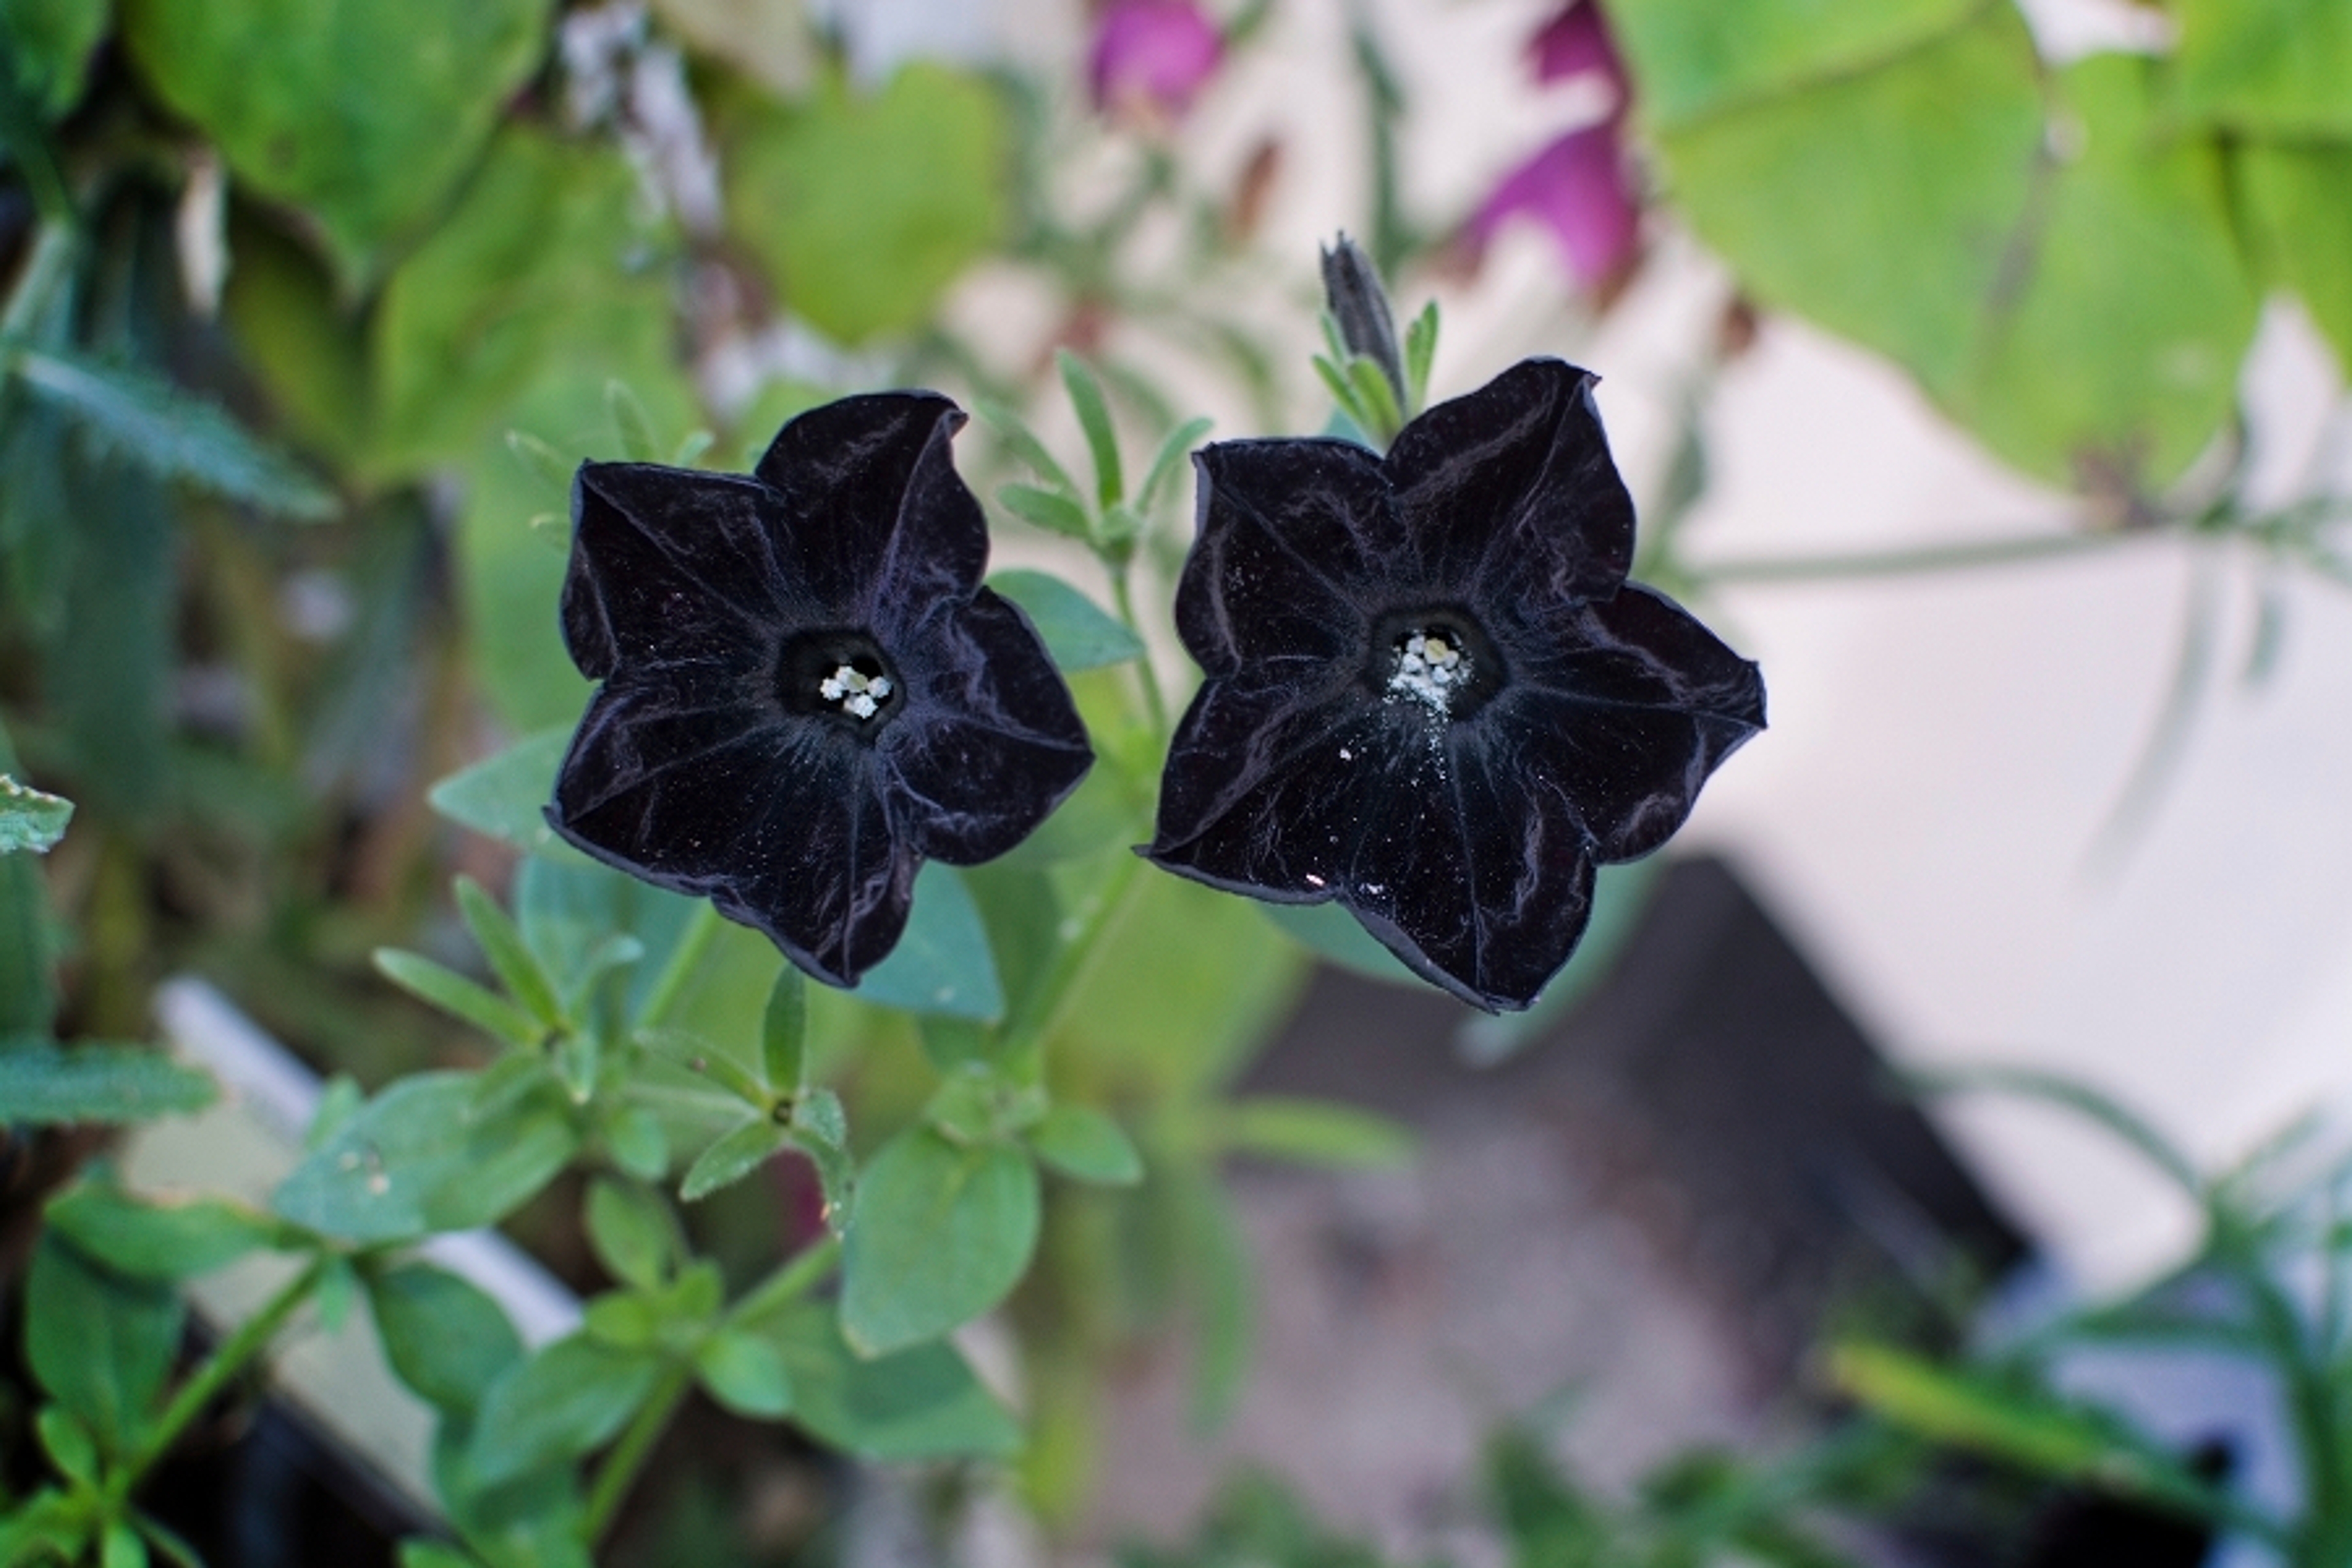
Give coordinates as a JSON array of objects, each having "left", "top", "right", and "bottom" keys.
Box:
[{"left": 1470, "top": 0, "right": 1642, "bottom": 289}]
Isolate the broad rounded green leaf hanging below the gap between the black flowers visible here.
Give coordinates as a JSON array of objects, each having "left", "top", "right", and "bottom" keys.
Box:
[{"left": 842, "top": 1126, "right": 1037, "bottom": 1354}]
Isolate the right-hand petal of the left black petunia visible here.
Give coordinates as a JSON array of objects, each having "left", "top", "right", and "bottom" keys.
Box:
[{"left": 877, "top": 588, "right": 1094, "bottom": 865}]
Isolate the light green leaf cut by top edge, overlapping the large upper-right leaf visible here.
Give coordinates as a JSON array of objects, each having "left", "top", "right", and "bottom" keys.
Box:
[{"left": 1609, "top": 0, "right": 1985, "bottom": 127}]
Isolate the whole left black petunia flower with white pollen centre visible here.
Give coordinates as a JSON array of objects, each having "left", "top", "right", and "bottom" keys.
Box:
[{"left": 548, "top": 393, "right": 1094, "bottom": 985}]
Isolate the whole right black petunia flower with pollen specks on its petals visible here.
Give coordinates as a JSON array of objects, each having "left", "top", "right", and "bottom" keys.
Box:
[{"left": 1143, "top": 360, "right": 1764, "bottom": 1009}]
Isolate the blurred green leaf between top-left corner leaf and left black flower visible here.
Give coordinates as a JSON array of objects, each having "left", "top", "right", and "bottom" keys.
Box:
[{"left": 374, "top": 127, "right": 666, "bottom": 472}]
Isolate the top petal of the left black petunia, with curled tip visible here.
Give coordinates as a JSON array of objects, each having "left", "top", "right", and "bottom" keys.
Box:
[{"left": 755, "top": 393, "right": 988, "bottom": 625}]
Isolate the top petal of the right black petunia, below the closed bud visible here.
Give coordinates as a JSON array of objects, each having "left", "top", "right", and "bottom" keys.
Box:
[{"left": 1388, "top": 360, "right": 1632, "bottom": 602}]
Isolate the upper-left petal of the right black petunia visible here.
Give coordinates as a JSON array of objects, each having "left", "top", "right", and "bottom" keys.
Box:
[{"left": 1176, "top": 440, "right": 1404, "bottom": 675}]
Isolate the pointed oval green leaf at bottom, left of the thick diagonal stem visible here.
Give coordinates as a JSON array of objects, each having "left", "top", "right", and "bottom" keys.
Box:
[{"left": 466, "top": 1333, "right": 661, "bottom": 1486}]
